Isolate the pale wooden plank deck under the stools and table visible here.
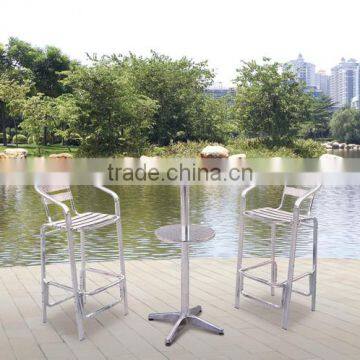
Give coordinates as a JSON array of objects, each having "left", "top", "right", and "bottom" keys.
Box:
[{"left": 0, "top": 258, "right": 360, "bottom": 360}]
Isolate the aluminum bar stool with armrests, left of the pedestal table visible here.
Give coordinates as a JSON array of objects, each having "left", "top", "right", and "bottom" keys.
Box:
[{"left": 35, "top": 185, "right": 128, "bottom": 340}]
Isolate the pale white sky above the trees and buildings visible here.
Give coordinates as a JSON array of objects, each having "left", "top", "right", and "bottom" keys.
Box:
[{"left": 0, "top": 0, "right": 360, "bottom": 86}]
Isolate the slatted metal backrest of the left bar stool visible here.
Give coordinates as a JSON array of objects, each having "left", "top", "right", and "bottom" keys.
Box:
[{"left": 36, "top": 185, "right": 77, "bottom": 222}]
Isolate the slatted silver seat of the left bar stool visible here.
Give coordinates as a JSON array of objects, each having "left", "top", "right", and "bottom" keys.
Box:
[{"left": 49, "top": 212, "right": 119, "bottom": 231}]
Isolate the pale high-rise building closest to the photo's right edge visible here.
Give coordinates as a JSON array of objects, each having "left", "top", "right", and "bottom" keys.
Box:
[{"left": 330, "top": 58, "right": 359, "bottom": 107}]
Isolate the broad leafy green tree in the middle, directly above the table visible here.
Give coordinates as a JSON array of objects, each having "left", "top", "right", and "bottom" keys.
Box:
[{"left": 117, "top": 52, "right": 214, "bottom": 145}]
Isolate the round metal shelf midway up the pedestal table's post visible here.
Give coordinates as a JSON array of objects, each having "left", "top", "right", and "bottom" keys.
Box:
[{"left": 155, "top": 224, "right": 215, "bottom": 243}]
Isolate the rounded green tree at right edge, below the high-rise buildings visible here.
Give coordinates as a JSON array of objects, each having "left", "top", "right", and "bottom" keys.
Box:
[{"left": 330, "top": 109, "right": 360, "bottom": 143}]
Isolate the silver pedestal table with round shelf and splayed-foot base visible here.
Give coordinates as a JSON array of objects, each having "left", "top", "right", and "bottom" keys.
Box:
[{"left": 149, "top": 185, "right": 224, "bottom": 346}]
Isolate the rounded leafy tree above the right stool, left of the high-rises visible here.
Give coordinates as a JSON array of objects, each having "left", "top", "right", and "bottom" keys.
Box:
[{"left": 234, "top": 58, "right": 311, "bottom": 140}]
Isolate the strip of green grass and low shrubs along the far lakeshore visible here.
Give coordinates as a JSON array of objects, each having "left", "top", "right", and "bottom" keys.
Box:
[{"left": 0, "top": 138, "right": 326, "bottom": 158}]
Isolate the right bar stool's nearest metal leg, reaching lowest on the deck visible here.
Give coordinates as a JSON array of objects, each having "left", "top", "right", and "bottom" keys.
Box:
[{"left": 281, "top": 221, "right": 298, "bottom": 330}]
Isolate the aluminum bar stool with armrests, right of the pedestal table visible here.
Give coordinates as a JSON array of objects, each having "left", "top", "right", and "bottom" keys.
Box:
[{"left": 235, "top": 185, "right": 320, "bottom": 329}]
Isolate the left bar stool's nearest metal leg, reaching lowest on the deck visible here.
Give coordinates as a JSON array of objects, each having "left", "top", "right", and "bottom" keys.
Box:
[{"left": 67, "top": 227, "right": 85, "bottom": 340}]
